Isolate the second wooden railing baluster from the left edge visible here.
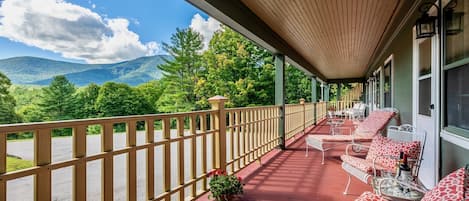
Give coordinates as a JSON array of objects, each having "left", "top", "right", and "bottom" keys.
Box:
[{"left": 34, "top": 129, "right": 52, "bottom": 201}]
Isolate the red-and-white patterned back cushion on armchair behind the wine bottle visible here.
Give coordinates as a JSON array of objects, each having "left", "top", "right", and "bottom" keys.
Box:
[{"left": 366, "top": 136, "right": 420, "bottom": 169}]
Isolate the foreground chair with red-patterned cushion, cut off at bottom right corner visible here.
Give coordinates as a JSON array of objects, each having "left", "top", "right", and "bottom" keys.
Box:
[{"left": 355, "top": 165, "right": 469, "bottom": 201}]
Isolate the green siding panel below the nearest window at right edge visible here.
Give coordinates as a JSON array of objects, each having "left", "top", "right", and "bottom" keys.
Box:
[{"left": 440, "top": 139, "right": 469, "bottom": 177}]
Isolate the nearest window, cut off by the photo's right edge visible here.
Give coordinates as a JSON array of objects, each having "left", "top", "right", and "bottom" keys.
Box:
[{"left": 443, "top": 0, "right": 469, "bottom": 138}]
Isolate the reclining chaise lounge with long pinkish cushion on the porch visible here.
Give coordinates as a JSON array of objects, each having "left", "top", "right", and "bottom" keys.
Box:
[{"left": 305, "top": 108, "right": 400, "bottom": 164}]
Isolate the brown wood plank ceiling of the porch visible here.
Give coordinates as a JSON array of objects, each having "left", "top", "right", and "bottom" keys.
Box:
[{"left": 241, "top": 0, "right": 399, "bottom": 79}]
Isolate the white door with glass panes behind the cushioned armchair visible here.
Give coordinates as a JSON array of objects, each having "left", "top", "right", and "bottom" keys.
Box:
[{"left": 413, "top": 31, "right": 439, "bottom": 188}]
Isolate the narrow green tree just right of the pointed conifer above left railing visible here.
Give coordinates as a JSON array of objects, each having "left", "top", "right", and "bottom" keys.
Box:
[{"left": 75, "top": 83, "right": 100, "bottom": 119}]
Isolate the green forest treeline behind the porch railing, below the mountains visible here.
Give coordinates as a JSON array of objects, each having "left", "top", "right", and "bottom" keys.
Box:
[{"left": 0, "top": 27, "right": 348, "bottom": 139}]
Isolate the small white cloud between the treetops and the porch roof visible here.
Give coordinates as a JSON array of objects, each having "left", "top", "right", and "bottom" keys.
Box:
[{"left": 189, "top": 13, "right": 221, "bottom": 49}]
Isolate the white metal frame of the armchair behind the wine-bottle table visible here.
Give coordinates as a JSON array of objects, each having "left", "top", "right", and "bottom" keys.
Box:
[{"left": 341, "top": 125, "right": 426, "bottom": 194}]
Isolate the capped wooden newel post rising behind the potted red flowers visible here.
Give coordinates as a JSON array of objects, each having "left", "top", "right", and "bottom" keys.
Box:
[{"left": 208, "top": 96, "right": 228, "bottom": 171}]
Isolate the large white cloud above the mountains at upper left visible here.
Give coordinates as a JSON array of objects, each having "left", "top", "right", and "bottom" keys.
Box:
[{"left": 0, "top": 0, "right": 161, "bottom": 63}]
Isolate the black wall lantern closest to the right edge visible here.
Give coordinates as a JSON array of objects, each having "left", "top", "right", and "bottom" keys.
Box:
[{"left": 445, "top": 0, "right": 464, "bottom": 35}]
